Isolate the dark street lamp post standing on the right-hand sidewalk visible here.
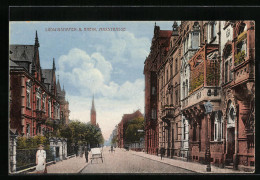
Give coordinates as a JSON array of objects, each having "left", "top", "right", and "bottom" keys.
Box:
[{"left": 204, "top": 101, "right": 213, "bottom": 172}]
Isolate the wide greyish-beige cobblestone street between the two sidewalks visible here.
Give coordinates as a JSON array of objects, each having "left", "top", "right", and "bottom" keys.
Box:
[{"left": 81, "top": 148, "right": 194, "bottom": 173}]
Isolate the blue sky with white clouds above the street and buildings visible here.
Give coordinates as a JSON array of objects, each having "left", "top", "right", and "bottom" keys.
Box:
[{"left": 9, "top": 21, "right": 173, "bottom": 140}]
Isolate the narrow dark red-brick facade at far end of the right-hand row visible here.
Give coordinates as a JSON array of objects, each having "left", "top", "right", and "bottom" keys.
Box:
[{"left": 143, "top": 24, "right": 172, "bottom": 154}]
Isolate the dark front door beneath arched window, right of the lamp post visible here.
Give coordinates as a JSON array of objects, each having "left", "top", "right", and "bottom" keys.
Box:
[{"left": 226, "top": 127, "right": 235, "bottom": 162}]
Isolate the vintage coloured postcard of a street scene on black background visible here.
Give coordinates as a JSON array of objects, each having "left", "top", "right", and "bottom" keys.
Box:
[{"left": 9, "top": 19, "right": 255, "bottom": 175}]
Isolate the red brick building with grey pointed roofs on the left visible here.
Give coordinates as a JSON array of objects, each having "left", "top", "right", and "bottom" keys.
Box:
[{"left": 9, "top": 32, "right": 69, "bottom": 136}]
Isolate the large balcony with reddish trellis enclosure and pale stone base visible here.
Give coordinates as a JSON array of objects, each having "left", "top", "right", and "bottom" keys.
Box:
[{"left": 182, "top": 44, "right": 220, "bottom": 108}]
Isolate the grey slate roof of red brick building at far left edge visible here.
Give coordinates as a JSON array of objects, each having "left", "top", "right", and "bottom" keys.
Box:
[{"left": 9, "top": 45, "right": 34, "bottom": 62}]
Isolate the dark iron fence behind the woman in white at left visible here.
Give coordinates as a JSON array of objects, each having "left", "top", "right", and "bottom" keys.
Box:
[{"left": 16, "top": 148, "right": 54, "bottom": 171}]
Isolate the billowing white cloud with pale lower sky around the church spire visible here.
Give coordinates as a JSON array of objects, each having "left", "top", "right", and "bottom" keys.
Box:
[{"left": 58, "top": 48, "right": 144, "bottom": 139}]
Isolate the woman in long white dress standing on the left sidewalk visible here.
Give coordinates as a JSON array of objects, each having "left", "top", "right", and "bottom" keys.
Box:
[{"left": 36, "top": 144, "right": 47, "bottom": 173}]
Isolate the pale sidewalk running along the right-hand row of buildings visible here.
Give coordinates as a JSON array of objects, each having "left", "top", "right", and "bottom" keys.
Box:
[{"left": 130, "top": 151, "right": 248, "bottom": 174}]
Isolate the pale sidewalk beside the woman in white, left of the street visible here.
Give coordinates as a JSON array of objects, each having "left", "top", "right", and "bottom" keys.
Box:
[{"left": 47, "top": 155, "right": 88, "bottom": 174}]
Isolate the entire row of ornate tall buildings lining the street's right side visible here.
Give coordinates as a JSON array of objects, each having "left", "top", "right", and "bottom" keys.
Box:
[{"left": 144, "top": 21, "right": 255, "bottom": 170}]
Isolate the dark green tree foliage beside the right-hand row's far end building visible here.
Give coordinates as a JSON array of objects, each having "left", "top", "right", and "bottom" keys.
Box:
[{"left": 124, "top": 117, "right": 144, "bottom": 143}]
